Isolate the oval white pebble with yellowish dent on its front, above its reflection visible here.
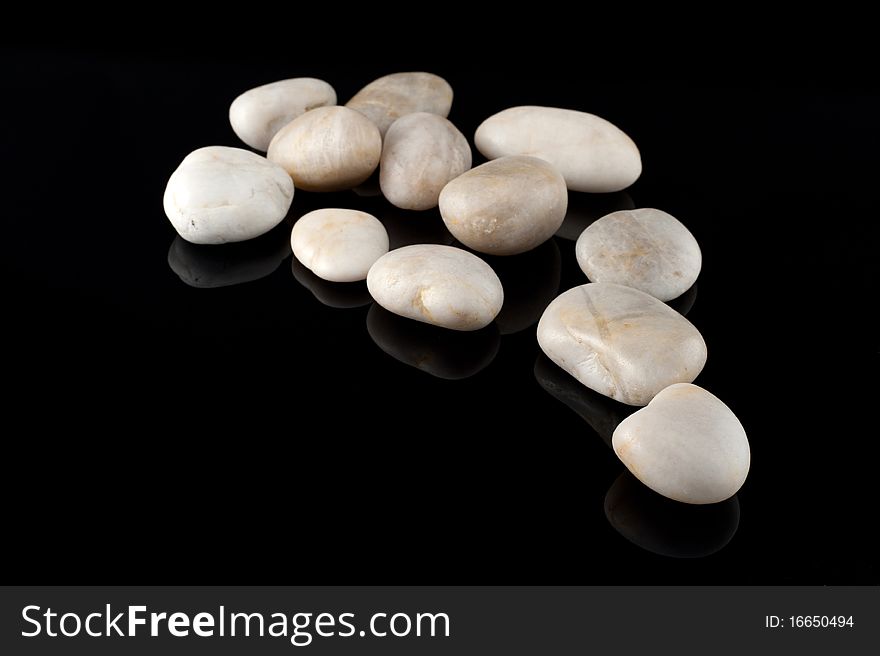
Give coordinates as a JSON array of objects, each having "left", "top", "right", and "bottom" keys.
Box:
[{"left": 367, "top": 244, "right": 504, "bottom": 330}]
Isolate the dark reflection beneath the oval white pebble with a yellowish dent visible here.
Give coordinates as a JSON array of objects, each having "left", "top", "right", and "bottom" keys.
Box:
[{"left": 367, "top": 303, "right": 501, "bottom": 380}]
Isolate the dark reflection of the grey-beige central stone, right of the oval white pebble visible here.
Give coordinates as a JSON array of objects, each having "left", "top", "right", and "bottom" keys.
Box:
[{"left": 477, "top": 239, "right": 562, "bottom": 335}]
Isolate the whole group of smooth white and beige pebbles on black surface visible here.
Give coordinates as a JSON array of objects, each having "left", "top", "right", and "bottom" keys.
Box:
[{"left": 164, "top": 73, "right": 750, "bottom": 504}]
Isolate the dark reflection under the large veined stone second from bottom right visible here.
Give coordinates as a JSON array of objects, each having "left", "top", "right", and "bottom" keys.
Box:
[{"left": 535, "top": 353, "right": 638, "bottom": 448}]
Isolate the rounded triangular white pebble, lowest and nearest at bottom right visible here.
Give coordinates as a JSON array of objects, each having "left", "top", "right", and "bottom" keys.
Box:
[{"left": 611, "top": 383, "right": 751, "bottom": 504}]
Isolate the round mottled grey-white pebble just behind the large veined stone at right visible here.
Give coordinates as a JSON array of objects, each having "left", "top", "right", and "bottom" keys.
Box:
[{"left": 575, "top": 208, "right": 703, "bottom": 301}]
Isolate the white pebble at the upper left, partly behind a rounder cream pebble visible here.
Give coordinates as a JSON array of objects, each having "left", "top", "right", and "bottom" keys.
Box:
[{"left": 229, "top": 77, "right": 336, "bottom": 152}]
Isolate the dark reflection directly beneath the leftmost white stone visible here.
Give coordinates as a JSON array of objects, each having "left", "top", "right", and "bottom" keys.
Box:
[{"left": 168, "top": 223, "right": 290, "bottom": 288}]
